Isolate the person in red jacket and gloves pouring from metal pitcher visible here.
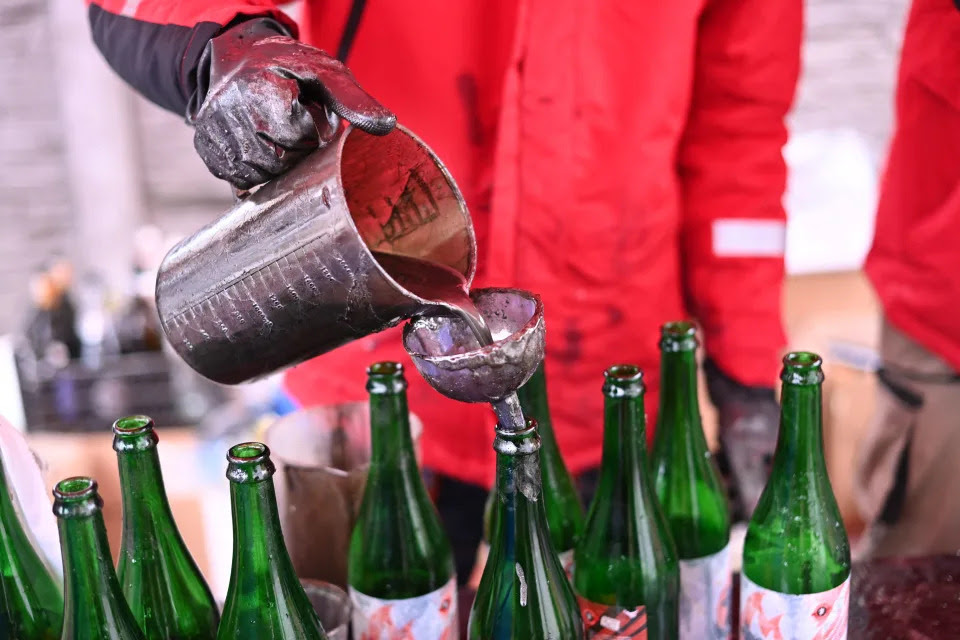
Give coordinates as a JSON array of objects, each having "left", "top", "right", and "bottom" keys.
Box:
[{"left": 88, "top": 0, "right": 802, "bottom": 577}]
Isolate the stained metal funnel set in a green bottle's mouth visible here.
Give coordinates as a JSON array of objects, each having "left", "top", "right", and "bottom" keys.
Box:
[{"left": 403, "top": 289, "right": 544, "bottom": 429}]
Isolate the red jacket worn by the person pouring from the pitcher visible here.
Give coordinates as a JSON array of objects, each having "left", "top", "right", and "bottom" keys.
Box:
[{"left": 91, "top": 0, "right": 802, "bottom": 483}]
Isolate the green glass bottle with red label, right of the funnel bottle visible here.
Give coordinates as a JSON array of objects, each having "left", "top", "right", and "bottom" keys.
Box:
[{"left": 573, "top": 365, "right": 680, "bottom": 640}]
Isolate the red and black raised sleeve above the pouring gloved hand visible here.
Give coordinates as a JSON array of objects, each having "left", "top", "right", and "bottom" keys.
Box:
[{"left": 86, "top": 0, "right": 297, "bottom": 114}]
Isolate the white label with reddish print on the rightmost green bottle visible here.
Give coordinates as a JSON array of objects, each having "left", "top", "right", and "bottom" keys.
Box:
[{"left": 740, "top": 574, "right": 850, "bottom": 640}]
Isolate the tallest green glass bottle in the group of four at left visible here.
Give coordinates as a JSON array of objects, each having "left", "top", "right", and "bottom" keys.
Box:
[{"left": 113, "top": 416, "right": 219, "bottom": 640}]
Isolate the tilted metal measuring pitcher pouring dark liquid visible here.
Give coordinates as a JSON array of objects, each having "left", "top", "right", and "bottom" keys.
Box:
[{"left": 156, "top": 126, "right": 477, "bottom": 384}]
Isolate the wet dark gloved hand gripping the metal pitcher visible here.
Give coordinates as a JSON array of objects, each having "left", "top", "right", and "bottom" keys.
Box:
[{"left": 187, "top": 18, "right": 397, "bottom": 189}]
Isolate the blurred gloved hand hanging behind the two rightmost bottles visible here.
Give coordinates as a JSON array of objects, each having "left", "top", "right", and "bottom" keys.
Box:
[{"left": 703, "top": 359, "right": 780, "bottom": 522}]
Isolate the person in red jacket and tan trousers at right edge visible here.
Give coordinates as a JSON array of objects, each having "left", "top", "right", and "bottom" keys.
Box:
[{"left": 856, "top": 0, "right": 960, "bottom": 556}]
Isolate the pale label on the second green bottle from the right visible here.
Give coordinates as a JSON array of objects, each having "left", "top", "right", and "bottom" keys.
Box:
[{"left": 680, "top": 543, "right": 733, "bottom": 640}]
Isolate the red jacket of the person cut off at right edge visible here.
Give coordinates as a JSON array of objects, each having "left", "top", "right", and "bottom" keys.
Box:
[{"left": 866, "top": 0, "right": 960, "bottom": 371}]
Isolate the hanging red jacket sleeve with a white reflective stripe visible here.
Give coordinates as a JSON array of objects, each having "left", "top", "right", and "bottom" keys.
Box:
[{"left": 678, "top": 0, "right": 802, "bottom": 386}]
